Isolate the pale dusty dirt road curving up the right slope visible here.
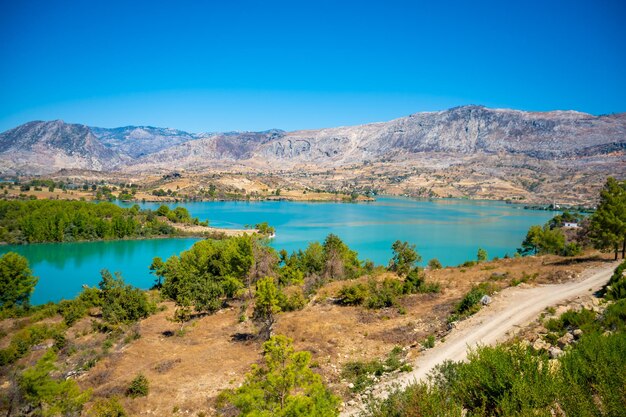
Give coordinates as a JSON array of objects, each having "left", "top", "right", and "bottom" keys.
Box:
[{"left": 341, "top": 262, "right": 619, "bottom": 416}]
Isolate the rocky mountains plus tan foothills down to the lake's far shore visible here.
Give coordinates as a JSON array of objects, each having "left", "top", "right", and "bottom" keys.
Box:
[{"left": 0, "top": 106, "right": 626, "bottom": 204}]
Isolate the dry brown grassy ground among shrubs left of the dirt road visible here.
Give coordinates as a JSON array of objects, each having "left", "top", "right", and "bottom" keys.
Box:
[{"left": 0, "top": 253, "right": 605, "bottom": 415}]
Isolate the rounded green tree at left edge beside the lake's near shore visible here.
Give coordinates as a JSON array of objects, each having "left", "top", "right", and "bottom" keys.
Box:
[{"left": 0, "top": 252, "right": 38, "bottom": 308}]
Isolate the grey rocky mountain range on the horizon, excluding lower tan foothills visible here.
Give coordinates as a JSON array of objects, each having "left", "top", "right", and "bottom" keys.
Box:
[{"left": 0, "top": 106, "right": 626, "bottom": 188}]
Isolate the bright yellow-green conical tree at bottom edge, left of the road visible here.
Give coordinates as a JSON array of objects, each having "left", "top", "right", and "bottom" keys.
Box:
[{"left": 219, "top": 336, "right": 340, "bottom": 417}]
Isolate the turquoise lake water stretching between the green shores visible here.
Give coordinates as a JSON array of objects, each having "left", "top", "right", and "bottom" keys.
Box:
[{"left": 0, "top": 197, "right": 554, "bottom": 304}]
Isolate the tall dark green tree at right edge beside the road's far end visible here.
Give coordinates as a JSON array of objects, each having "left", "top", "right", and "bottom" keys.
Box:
[{"left": 589, "top": 177, "right": 626, "bottom": 260}]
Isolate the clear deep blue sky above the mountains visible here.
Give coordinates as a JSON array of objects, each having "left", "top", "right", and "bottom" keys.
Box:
[{"left": 0, "top": 0, "right": 626, "bottom": 132}]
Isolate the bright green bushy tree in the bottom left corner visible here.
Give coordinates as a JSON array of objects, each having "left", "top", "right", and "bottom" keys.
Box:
[{"left": 19, "top": 350, "right": 91, "bottom": 416}]
